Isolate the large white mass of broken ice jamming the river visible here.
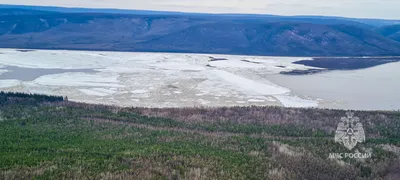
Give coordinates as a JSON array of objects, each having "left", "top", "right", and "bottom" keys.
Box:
[{"left": 0, "top": 49, "right": 322, "bottom": 107}]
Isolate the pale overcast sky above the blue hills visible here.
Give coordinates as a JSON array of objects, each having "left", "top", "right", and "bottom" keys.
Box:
[{"left": 0, "top": 0, "right": 400, "bottom": 19}]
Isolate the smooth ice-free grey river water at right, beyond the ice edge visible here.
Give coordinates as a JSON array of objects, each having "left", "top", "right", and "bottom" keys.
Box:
[{"left": 268, "top": 63, "right": 400, "bottom": 110}]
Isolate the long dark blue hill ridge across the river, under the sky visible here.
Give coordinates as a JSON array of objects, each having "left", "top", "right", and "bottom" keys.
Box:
[{"left": 0, "top": 6, "right": 400, "bottom": 56}]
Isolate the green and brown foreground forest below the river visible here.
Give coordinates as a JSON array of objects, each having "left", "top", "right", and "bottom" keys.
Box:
[{"left": 0, "top": 92, "right": 400, "bottom": 180}]
